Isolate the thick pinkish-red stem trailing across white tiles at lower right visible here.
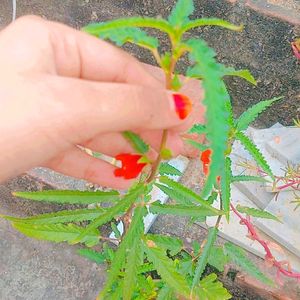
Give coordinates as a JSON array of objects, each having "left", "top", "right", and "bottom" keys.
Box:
[{"left": 230, "top": 204, "right": 300, "bottom": 280}]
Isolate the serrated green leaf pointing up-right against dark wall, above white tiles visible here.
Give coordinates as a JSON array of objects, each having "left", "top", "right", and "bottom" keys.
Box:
[{"left": 235, "top": 97, "right": 283, "bottom": 131}]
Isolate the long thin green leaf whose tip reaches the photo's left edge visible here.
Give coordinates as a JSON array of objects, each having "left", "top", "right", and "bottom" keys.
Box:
[{"left": 1, "top": 208, "right": 104, "bottom": 225}]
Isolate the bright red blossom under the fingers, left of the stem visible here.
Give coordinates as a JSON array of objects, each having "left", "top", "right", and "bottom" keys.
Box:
[{"left": 114, "top": 153, "right": 146, "bottom": 179}]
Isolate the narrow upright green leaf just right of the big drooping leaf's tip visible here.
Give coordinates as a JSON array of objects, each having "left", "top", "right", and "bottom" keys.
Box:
[{"left": 221, "top": 157, "right": 232, "bottom": 220}]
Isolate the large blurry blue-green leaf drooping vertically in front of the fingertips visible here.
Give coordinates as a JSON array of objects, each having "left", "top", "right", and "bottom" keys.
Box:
[{"left": 186, "top": 39, "right": 230, "bottom": 198}]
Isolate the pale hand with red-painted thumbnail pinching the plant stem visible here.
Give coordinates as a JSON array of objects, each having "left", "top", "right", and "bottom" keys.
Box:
[{"left": 0, "top": 16, "right": 203, "bottom": 189}]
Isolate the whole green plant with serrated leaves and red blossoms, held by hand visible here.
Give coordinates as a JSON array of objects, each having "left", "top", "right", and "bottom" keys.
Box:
[{"left": 3, "top": 0, "right": 300, "bottom": 300}]
